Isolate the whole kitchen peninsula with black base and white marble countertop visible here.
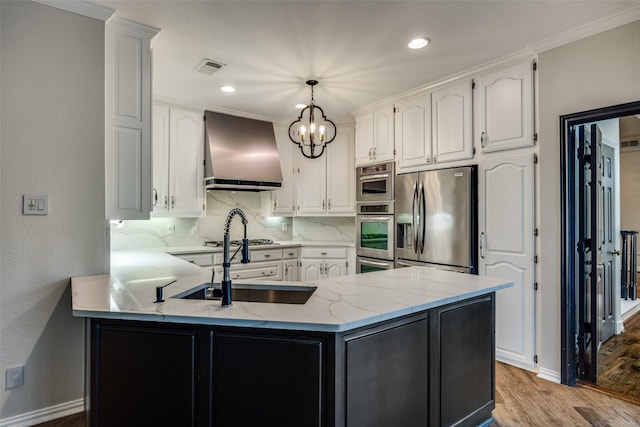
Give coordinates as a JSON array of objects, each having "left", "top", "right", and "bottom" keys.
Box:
[{"left": 72, "top": 251, "right": 512, "bottom": 426}]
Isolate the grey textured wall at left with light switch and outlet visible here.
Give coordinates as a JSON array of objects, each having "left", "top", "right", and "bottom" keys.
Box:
[{"left": 0, "top": 0, "right": 107, "bottom": 419}]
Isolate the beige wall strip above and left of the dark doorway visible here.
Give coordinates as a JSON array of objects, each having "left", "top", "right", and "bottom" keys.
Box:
[{"left": 538, "top": 21, "right": 640, "bottom": 374}]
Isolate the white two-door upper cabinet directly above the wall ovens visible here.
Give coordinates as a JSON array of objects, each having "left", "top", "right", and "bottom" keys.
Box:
[{"left": 355, "top": 105, "right": 395, "bottom": 166}]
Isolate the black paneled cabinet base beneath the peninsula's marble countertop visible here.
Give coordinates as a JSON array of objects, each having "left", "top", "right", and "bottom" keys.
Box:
[{"left": 90, "top": 293, "right": 495, "bottom": 427}]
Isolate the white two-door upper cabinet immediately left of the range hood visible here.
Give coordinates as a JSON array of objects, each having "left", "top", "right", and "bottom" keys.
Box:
[{"left": 152, "top": 105, "right": 205, "bottom": 217}]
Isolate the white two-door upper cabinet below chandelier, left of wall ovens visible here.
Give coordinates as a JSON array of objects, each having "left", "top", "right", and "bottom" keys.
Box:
[{"left": 297, "top": 127, "right": 355, "bottom": 216}]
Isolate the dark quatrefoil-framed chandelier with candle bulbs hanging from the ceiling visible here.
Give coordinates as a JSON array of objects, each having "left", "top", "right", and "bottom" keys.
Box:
[{"left": 289, "top": 80, "right": 336, "bottom": 159}]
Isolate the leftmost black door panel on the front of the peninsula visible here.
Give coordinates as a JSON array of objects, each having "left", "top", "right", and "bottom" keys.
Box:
[{"left": 90, "top": 321, "right": 201, "bottom": 427}]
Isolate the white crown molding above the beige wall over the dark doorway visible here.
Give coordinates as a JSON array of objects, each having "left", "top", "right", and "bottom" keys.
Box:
[{"left": 528, "top": 6, "right": 640, "bottom": 53}]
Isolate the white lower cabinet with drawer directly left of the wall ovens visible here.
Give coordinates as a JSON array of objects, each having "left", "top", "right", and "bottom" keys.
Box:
[{"left": 300, "top": 247, "right": 349, "bottom": 281}]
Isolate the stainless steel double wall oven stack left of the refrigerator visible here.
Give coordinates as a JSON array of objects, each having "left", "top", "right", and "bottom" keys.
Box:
[{"left": 356, "top": 162, "right": 395, "bottom": 273}]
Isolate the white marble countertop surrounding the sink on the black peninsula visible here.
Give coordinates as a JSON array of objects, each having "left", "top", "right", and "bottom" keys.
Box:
[{"left": 71, "top": 251, "right": 513, "bottom": 332}]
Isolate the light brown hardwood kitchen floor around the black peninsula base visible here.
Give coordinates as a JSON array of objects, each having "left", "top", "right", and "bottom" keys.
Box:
[{"left": 37, "top": 363, "right": 640, "bottom": 427}]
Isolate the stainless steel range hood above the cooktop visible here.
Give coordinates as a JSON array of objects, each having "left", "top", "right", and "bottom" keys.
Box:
[{"left": 204, "top": 111, "right": 282, "bottom": 191}]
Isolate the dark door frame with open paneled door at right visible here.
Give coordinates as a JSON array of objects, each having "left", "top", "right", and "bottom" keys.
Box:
[{"left": 560, "top": 102, "right": 640, "bottom": 398}]
